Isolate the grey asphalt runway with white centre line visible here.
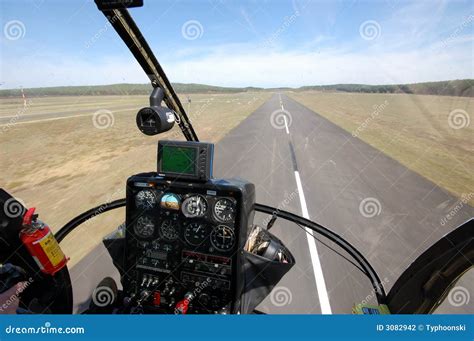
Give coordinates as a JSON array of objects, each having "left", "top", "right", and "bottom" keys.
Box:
[{"left": 71, "top": 94, "right": 474, "bottom": 314}]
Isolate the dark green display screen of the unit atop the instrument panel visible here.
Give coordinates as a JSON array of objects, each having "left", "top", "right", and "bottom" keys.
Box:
[{"left": 161, "top": 145, "right": 197, "bottom": 175}]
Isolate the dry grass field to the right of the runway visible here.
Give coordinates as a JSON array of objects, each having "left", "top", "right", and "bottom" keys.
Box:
[{"left": 288, "top": 91, "right": 474, "bottom": 205}]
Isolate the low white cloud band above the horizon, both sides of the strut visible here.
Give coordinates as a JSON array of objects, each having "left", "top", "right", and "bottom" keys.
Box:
[{"left": 2, "top": 37, "right": 474, "bottom": 88}]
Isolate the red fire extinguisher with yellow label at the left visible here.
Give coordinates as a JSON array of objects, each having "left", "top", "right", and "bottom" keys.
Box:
[{"left": 20, "top": 207, "right": 68, "bottom": 276}]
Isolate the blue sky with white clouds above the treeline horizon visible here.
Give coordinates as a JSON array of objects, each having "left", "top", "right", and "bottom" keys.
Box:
[{"left": 0, "top": 0, "right": 474, "bottom": 89}]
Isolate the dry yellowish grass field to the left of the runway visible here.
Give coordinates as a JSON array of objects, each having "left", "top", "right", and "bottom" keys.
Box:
[{"left": 0, "top": 92, "right": 270, "bottom": 264}]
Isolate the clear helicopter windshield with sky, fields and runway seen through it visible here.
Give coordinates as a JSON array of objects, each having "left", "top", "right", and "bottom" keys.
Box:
[{"left": 0, "top": 0, "right": 474, "bottom": 314}]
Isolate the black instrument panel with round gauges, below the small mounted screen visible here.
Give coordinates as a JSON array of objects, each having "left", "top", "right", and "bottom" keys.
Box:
[{"left": 123, "top": 176, "right": 254, "bottom": 313}]
